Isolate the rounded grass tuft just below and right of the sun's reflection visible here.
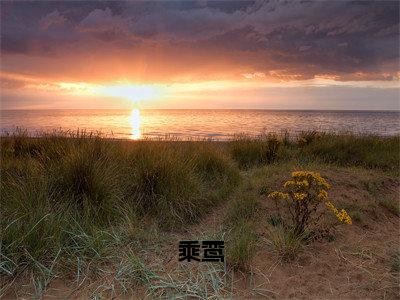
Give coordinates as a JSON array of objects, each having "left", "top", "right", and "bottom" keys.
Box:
[{"left": 126, "top": 144, "right": 209, "bottom": 227}]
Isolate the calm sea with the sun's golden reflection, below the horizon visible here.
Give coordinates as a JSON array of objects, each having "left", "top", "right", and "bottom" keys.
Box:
[{"left": 0, "top": 109, "right": 400, "bottom": 139}]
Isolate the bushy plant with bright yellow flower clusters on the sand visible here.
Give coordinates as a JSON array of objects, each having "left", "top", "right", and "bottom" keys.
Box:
[{"left": 268, "top": 171, "right": 352, "bottom": 234}]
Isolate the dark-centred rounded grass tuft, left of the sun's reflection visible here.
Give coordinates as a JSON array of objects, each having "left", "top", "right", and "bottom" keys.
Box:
[{"left": 46, "top": 145, "right": 123, "bottom": 225}]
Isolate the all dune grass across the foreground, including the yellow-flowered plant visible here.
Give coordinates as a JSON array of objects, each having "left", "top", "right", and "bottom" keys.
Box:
[{"left": 0, "top": 132, "right": 400, "bottom": 297}]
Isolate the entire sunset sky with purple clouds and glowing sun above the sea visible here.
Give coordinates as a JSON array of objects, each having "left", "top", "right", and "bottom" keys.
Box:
[{"left": 0, "top": 1, "right": 400, "bottom": 110}]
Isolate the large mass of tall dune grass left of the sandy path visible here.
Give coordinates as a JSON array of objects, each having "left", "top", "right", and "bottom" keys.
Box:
[{"left": 1, "top": 134, "right": 240, "bottom": 292}]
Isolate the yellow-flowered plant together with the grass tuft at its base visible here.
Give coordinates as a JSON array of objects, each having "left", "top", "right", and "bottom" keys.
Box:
[{"left": 267, "top": 171, "right": 352, "bottom": 260}]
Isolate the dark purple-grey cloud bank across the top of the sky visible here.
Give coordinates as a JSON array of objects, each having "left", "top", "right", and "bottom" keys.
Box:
[{"left": 1, "top": 1, "right": 399, "bottom": 80}]
